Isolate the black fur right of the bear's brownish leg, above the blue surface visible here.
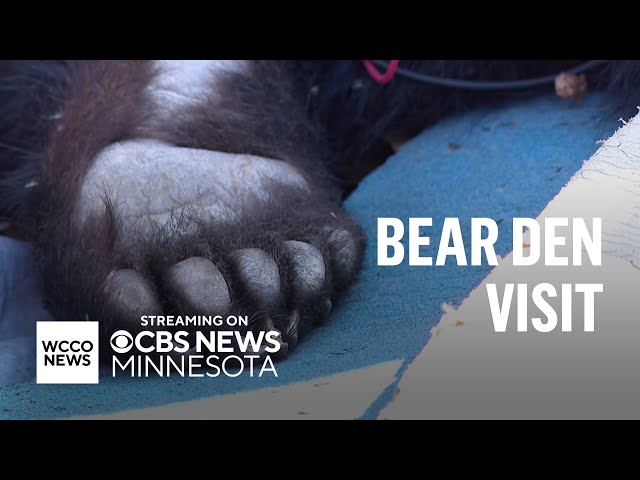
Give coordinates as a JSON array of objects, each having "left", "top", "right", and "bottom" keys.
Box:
[{"left": 289, "top": 60, "right": 640, "bottom": 188}]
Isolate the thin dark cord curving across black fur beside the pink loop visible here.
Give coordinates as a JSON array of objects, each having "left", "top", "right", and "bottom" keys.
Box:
[{"left": 372, "top": 60, "right": 607, "bottom": 90}]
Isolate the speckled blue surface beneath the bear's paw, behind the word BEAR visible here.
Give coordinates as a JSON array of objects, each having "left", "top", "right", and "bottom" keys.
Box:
[{"left": 0, "top": 94, "right": 633, "bottom": 418}]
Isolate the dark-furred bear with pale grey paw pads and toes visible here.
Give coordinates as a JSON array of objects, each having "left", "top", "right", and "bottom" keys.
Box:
[{"left": 0, "top": 60, "right": 640, "bottom": 356}]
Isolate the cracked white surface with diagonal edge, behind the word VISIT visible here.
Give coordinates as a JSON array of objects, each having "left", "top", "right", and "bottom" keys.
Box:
[{"left": 379, "top": 110, "right": 640, "bottom": 419}]
